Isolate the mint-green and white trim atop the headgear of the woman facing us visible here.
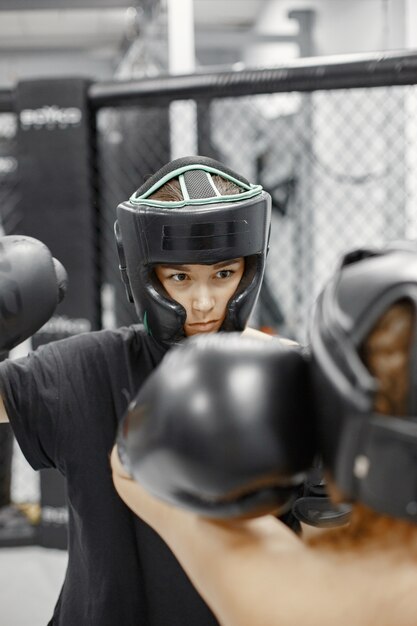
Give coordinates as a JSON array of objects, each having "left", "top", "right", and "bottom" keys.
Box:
[{"left": 129, "top": 164, "right": 262, "bottom": 208}]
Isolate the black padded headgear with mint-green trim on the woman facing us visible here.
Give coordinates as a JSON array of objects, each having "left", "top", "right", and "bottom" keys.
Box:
[{"left": 115, "top": 156, "right": 271, "bottom": 346}]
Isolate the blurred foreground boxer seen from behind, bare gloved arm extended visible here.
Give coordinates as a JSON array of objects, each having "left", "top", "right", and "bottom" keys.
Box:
[{"left": 112, "top": 243, "right": 417, "bottom": 626}]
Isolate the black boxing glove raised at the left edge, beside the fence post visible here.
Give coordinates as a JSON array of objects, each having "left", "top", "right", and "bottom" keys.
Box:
[{"left": 0, "top": 235, "right": 67, "bottom": 350}]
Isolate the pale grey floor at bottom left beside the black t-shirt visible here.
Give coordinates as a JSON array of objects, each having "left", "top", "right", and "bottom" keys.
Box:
[{"left": 0, "top": 547, "right": 67, "bottom": 626}]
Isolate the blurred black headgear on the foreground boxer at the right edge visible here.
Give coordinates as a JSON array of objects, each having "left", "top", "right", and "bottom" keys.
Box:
[{"left": 310, "top": 244, "right": 417, "bottom": 522}]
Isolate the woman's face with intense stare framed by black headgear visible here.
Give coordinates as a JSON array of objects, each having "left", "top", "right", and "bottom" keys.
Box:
[{"left": 155, "top": 257, "right": 245, "bottom": 337}]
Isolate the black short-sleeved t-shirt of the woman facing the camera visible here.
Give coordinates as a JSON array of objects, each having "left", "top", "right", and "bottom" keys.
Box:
[{"left": 0, "top": 326, "right": 217, "bottom": 626}]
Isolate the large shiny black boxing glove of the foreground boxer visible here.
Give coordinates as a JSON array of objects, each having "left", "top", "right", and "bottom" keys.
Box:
[{"left": 118, "top": 333, "right": 315, "bottom": 518}]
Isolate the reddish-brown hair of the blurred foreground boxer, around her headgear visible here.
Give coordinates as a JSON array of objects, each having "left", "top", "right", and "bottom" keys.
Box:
[{"left": 308, "top": 300, "right": 417, "bottom": 559}]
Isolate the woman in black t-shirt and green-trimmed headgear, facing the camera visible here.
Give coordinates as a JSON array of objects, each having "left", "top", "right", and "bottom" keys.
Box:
[{"left": 0, "top": 157, "right": 284, "bottom": 626}]
